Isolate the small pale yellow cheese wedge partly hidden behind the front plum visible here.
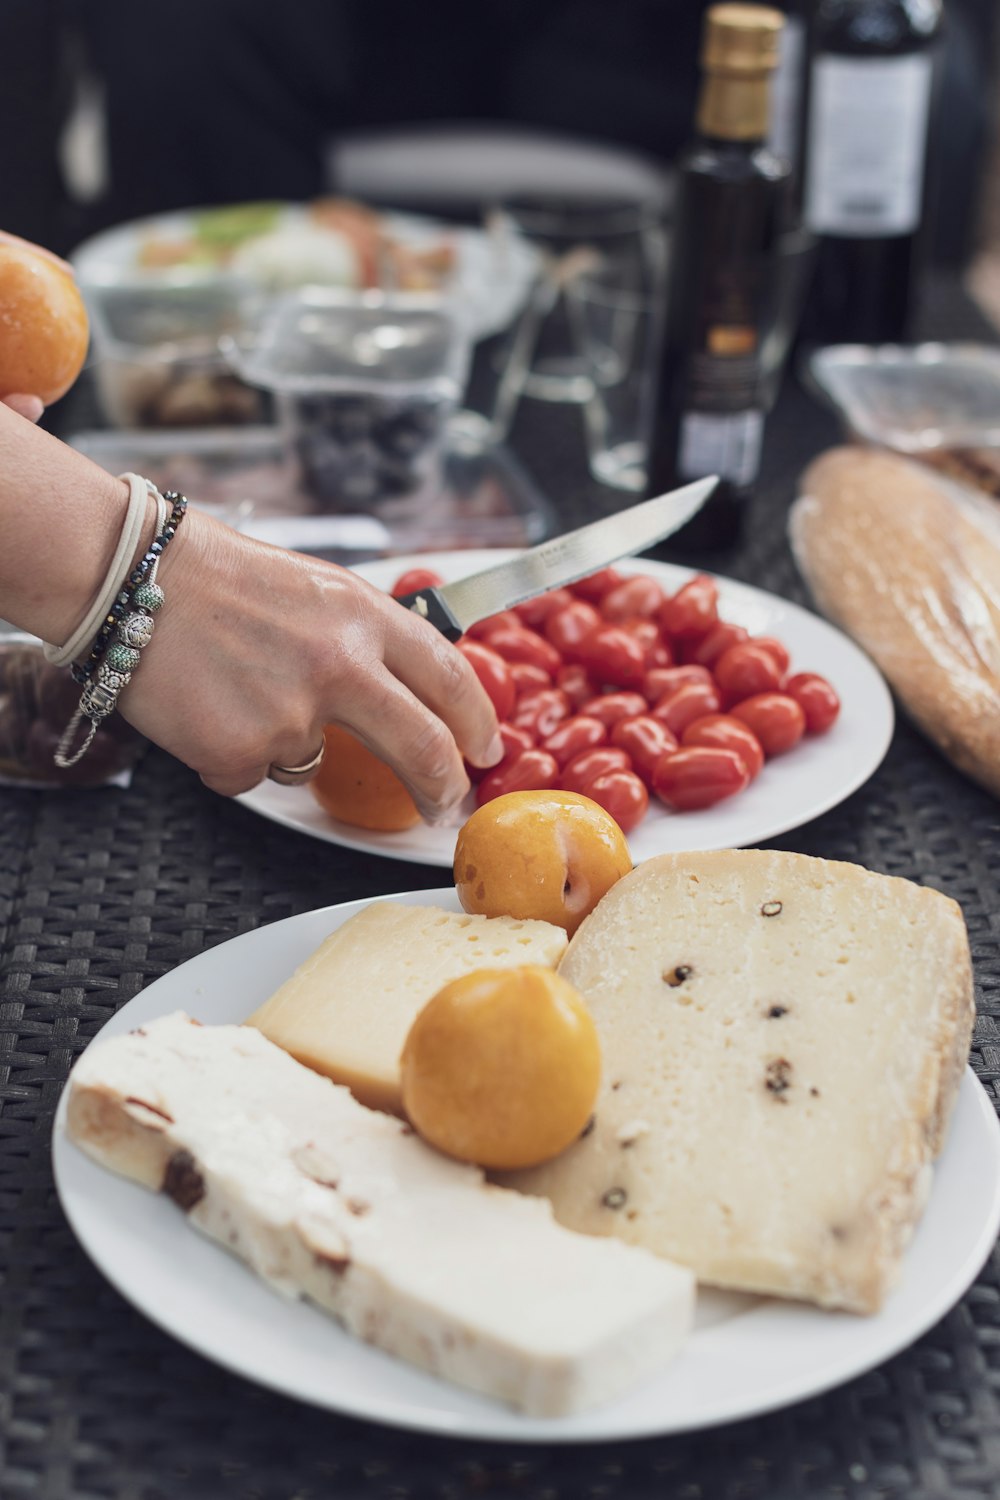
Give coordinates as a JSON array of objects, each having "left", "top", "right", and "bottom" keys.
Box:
[{"left": 247, "top": 902, "right": 567, "bottom": 1115}]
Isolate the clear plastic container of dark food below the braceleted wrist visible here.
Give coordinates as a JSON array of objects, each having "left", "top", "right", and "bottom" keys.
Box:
[{"left": 0, "top": 626, "right": 145, "bottom": 788}]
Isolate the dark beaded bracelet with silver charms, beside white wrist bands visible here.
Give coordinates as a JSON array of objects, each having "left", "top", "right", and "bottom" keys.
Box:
[{"left": 52, "top": 486, "right": 187, "bottom": 770}]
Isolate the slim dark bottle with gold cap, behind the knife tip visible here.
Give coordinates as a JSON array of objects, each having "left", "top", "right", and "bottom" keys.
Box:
[{"left": 649, "top": 5, "right": 790, "bottom": 551}]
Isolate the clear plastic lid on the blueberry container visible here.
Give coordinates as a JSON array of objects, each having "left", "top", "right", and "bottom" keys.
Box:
[{"left": 228, "top": 288, "right": 469, "bottom": 399}]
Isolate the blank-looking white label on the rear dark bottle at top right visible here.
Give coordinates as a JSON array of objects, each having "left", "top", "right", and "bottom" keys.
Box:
[{"left": 805, "top": 53, "right": 933, "bottom": 239}]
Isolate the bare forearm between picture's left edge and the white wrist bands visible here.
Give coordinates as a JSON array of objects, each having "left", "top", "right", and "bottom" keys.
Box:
[{"left": 0, "top": 404, "right": 129, "bottom": 645}]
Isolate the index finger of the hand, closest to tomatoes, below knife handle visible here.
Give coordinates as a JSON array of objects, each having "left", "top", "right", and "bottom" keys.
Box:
[{"left": 385, "top": 605, "right": 504, "bottom": 767}]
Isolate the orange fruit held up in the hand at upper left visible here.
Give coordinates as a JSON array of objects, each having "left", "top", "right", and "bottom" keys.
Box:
[{"left": 0, "top": 236, "right": 90, "bottom": 407}]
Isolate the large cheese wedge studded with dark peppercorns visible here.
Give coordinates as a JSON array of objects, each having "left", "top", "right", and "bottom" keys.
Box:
[{"left": 504, "top": 851, "right": 973, "bottom": 1311}]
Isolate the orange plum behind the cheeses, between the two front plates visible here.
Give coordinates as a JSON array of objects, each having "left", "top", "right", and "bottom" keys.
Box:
[{"left": 454, "top": 791, "right": 633, "bottom": 936}]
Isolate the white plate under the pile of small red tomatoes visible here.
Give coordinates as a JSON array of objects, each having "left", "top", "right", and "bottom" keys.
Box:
[{"left": 240, "top": 549, "right": 894, "bottom": 869}]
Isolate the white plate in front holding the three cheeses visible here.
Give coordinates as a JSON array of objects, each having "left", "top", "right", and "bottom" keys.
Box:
[{"left": 52, "top": 890, "right": 1000, "bottom": 1443}]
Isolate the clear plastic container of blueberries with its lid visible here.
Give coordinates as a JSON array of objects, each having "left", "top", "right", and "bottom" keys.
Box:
[{"left": 231, "top": 290, "right": 471, "bottom": 515}]
